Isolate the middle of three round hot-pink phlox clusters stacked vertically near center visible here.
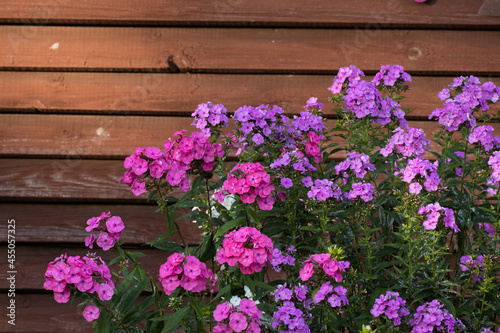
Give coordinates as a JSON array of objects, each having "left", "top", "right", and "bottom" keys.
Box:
[{"left": 217, "top": 227, "right": 273, "bottom": 274}]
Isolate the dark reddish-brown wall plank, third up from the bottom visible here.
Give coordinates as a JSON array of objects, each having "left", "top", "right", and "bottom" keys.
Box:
[{"left": 0, "top": 202, "right": 203, "bottom": 246}]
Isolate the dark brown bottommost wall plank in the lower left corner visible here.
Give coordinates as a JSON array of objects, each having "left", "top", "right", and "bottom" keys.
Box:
[{"left": 0, "top": 293, "right": 93, "bottom": 333}]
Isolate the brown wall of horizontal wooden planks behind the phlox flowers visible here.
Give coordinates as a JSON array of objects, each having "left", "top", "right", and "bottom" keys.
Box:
[{"left": 0, "top": 0, "right": 500, "bottom": 333}]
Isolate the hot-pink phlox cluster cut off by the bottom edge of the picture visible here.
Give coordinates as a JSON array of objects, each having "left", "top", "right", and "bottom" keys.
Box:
[{"left": 212, "top": 298, "right": 262, "bottom": 333}]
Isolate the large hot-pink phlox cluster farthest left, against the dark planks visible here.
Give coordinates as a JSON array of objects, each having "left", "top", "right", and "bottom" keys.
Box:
[{"left": 43, "top": 254, "right": 115, "bottom": 303}]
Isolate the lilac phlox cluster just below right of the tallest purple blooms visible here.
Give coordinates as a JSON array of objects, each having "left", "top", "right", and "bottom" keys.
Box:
[{"left": 380, "top": 127, "right": 430, "bottom": 158}]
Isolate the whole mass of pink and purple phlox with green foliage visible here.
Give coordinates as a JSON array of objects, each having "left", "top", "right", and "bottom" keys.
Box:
[{"left": 45, "top": 65, "right": 500, "bottom": 332}]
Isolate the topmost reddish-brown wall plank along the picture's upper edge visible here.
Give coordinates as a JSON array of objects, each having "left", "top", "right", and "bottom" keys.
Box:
[{"left": 0, "top": 0, "right": 499, "bottom": 29}]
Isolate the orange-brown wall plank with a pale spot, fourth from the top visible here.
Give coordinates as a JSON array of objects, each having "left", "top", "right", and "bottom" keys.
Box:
[{"left": 0, "top": 114, "right": 496, "bottom": 157}]
